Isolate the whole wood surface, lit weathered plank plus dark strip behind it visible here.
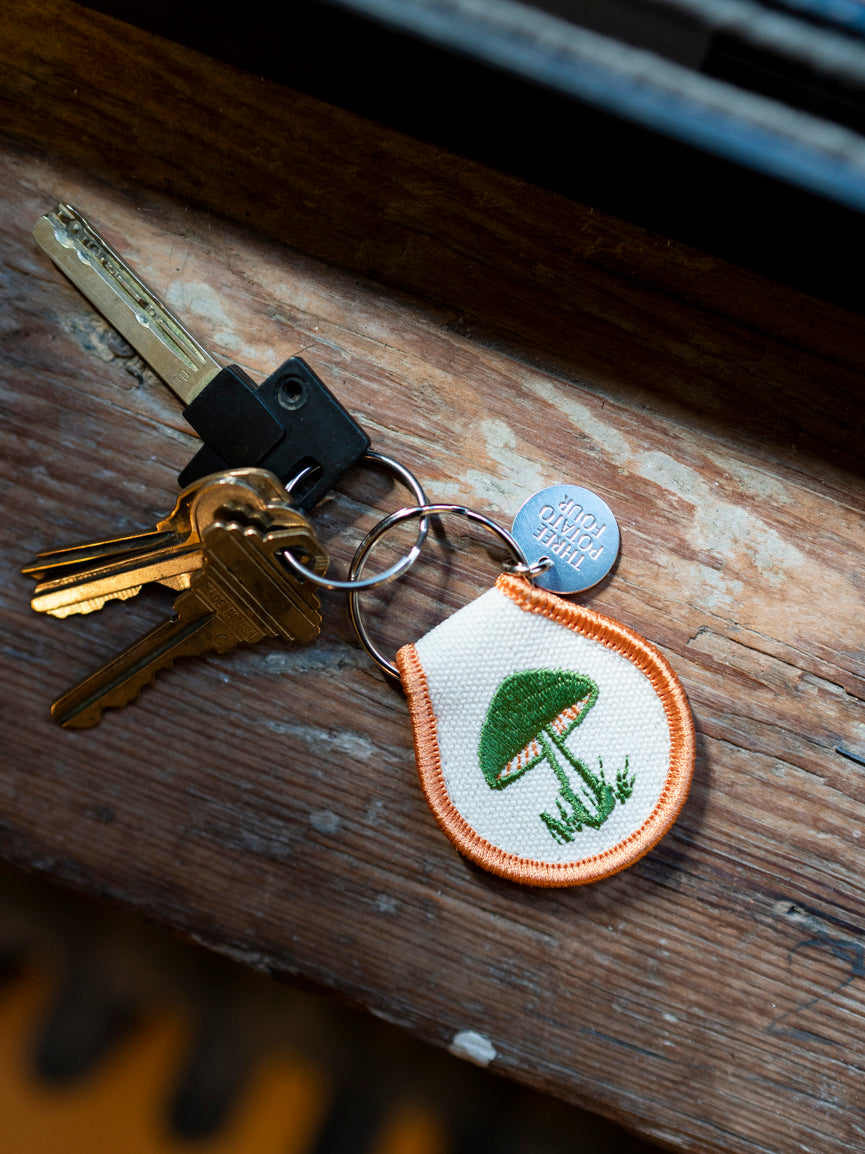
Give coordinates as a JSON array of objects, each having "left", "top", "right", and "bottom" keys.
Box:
[{"left": 0, "top": 3, "right": 865, "bottom": 1154}]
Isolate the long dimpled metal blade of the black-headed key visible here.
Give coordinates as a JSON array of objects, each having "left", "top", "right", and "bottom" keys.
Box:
[{"left": 33, "top": 204, "right": 221, "bottom": 405}]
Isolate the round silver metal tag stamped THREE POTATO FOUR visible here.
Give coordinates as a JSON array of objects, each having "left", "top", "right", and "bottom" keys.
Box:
[{"left": 513, "top": 485, "right": 619, "bottom": 593}]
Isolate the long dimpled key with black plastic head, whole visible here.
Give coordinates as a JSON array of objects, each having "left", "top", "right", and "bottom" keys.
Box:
[{"left": 33, "top": 204, "right": 369, "bottom": 511}]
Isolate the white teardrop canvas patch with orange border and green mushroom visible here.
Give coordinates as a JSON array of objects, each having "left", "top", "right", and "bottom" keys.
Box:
[{"left": 397, "top": 575, "right": 694, "bottom": 885}]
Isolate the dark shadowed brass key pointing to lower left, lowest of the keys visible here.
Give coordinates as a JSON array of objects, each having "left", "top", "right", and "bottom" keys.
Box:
[{"left": 51, "top": 512, "right": 328, "bottom": 729}]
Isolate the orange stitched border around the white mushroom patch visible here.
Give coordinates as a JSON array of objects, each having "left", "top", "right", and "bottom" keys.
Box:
[{"left": 397, "top": 574, "right": 695, "bottom": 886}]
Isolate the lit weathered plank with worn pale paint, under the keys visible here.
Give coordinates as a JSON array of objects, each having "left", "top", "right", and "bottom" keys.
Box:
[{"left": 0, "top": 144, "right": 865, "bottom": 1149}]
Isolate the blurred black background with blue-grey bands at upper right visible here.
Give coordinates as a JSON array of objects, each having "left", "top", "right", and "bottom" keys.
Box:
[{"left": 77, "top": 0, "right": 865, "bottom": 309}]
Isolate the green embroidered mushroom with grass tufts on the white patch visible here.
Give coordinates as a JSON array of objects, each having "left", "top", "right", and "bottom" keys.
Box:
[{"left": 477, "top": 669, "right": 634, "bottom": 844}]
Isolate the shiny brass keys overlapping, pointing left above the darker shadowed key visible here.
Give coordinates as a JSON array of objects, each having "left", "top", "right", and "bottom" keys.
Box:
[{"left": 22, "top": 469, "right": 295, "bottom": 617}]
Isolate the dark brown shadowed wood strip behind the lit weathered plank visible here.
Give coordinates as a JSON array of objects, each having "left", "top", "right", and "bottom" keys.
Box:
[{"left": 0, "top": 0, "right": 865, "bottom": 471}]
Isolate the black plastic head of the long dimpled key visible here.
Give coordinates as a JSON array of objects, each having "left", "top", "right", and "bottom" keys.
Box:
[{"left": 179, "top": 357, "right": 369, "bottom": 510}]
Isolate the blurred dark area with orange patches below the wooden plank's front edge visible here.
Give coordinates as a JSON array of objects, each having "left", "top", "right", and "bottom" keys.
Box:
[{"left": 0, "top": 866, "right": 653, "bottom": 1154}]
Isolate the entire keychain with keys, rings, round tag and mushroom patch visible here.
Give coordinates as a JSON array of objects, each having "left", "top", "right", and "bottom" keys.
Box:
[{"left": 37, "top": 193, "right": 694, "bottom": 867}]
